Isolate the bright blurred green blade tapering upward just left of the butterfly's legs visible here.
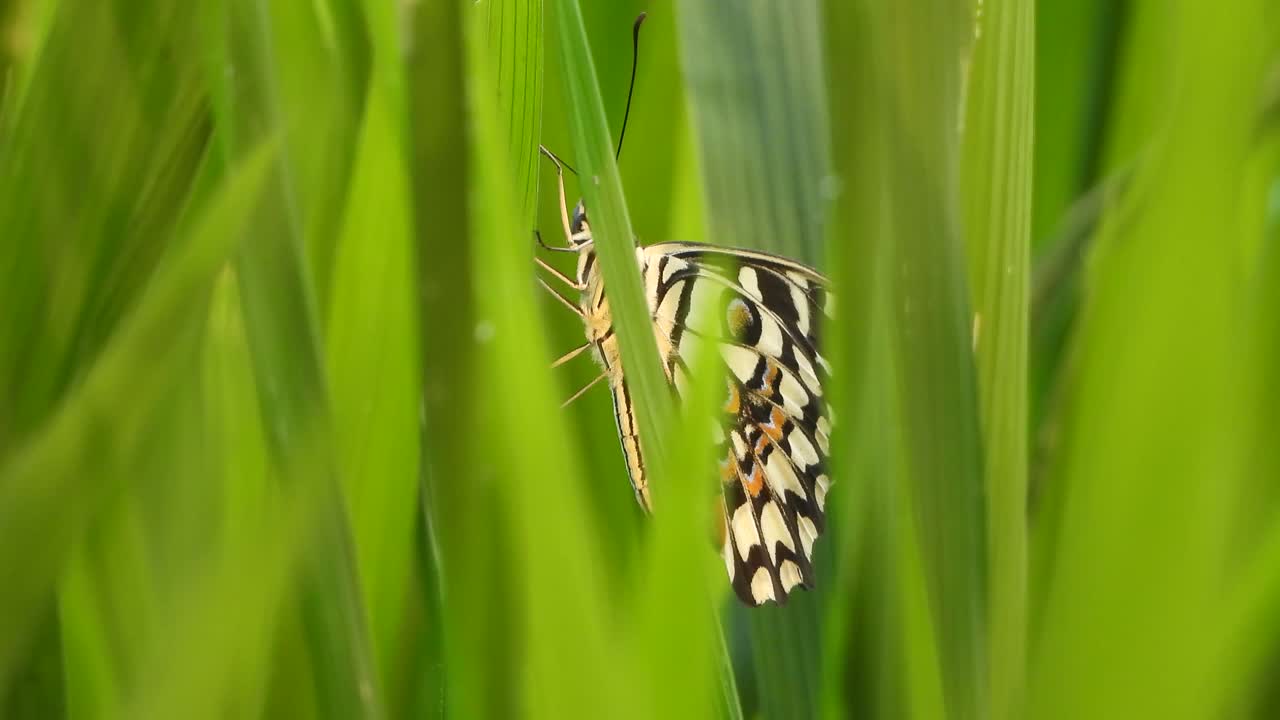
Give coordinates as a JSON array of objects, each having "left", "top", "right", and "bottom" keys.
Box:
[{"left": 465, "top": 2, "right": 634, "bottom": 717}]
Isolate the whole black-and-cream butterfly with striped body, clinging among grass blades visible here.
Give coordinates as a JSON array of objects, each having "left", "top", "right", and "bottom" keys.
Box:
[{"left": 535, "top": 142, "right": 832, "bottom": 606}]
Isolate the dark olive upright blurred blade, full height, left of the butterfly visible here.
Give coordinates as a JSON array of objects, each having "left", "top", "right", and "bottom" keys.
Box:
[{"left": 404, "top": 1, "right": 476, "bottom": 717}]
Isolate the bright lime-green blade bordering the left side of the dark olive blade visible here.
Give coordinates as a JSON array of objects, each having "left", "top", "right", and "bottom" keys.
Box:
[{"left": 325, "top": 3, "right": 421, "bottom": 714}]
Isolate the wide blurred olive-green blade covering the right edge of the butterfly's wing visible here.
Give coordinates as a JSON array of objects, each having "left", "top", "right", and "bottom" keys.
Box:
[{"left": 823, "top": 0, "right": 916, "bottom": 719}]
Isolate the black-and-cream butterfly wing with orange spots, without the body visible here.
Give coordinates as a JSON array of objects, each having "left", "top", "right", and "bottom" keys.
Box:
[{"left": 640, "top": 243, "right": 831, "bottom": 605}]
